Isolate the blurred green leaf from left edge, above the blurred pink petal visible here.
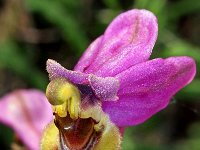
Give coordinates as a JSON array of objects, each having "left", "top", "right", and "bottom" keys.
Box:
[{"left": 0, "top": 41, "right": 47, "bottom": 89}]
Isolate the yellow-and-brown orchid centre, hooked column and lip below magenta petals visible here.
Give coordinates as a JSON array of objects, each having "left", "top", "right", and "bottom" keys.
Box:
[{"left": 41, "top": 78, "right": 121, "bottom": 150}]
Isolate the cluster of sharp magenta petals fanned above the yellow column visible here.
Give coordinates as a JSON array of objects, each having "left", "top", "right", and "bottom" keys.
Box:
[{"left": 47, "top": 9, "right": 196, "bottom": 127}]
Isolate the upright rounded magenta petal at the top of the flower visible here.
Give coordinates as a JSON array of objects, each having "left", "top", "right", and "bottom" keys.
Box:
[{"left": 76, "top": 9, "right": 158, "bottom": 77}]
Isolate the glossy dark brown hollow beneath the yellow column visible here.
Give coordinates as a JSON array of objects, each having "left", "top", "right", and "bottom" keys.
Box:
[{"left": 55, "top": 114, "right": 95, "bottom": 150}]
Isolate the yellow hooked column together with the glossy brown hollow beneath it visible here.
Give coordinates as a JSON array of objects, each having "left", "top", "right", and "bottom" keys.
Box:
[{"left": 46, "top": 78, "right": 101, "bottom": 149}]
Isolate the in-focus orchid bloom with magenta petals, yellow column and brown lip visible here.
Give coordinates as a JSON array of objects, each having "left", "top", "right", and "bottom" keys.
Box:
[{"left": 0, "top": 9, "right": 196, "bottom": 150}]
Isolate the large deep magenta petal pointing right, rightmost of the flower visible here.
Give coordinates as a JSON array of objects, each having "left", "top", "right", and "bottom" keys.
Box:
[{"left": 103, "top": 57, "right": 196, "bottom": 127}]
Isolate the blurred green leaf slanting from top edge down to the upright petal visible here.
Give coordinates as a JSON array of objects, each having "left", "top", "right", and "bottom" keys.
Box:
[{"left": 26, "top": 0, "right": 88, "bottom": 55}]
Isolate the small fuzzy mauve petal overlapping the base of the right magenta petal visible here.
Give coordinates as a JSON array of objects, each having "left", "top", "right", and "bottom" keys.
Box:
[{"left": 88, "top": 75, "right": 119, "bottom": 101}]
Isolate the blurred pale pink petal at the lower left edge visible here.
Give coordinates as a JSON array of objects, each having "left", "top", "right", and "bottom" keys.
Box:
[{"left": 0, "top": 90, "right": 53, "bottom": 150}]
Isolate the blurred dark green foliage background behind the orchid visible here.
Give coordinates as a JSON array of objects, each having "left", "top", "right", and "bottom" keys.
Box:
[{"left": 0, "top": 0, "right": 200, "bottom": 150}]
